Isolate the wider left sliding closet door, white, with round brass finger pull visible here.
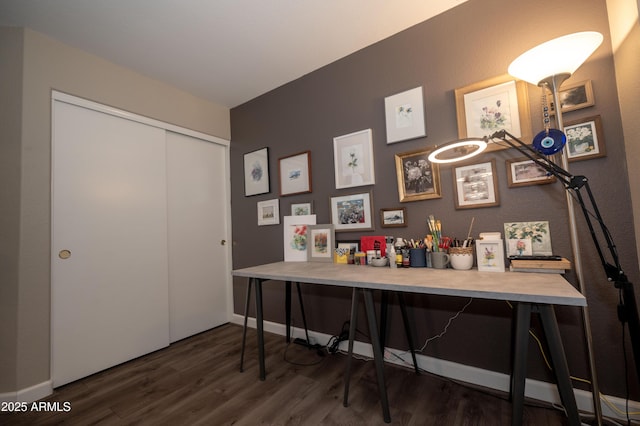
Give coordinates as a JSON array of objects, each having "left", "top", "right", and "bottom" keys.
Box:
[{"left": 51, "top": 101, "right": 169, "bottom": 387}]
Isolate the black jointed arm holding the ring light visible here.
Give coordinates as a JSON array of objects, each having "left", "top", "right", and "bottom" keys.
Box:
[{"left": 488, "top": 130, "right": 640, "bottom": 383}]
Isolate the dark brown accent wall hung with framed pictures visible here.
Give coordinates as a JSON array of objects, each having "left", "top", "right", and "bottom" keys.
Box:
[{"left": 231, "top": 0, "right": 640, "bottom": 400}]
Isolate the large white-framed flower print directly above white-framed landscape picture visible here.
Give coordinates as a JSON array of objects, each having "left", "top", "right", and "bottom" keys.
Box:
[{"left": 333, "top": 129, "right": 376, "bottom": 189}]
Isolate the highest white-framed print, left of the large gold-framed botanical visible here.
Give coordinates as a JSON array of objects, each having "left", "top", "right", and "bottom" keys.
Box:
[{"left": 384, "top": 86, "right": 426, "bottom": 144}]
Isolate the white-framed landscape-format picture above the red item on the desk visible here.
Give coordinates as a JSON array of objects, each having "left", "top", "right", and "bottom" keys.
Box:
[{"left": 331, "top": 192, "right": 373, "bottom": 232}]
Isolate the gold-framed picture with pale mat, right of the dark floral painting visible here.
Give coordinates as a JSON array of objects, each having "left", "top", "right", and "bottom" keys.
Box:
[{"left": 452, "top": 159, "right": 500, "bottom": 209}]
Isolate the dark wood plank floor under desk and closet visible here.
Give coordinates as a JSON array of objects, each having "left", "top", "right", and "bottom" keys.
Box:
[{"left": 0, "top": 324, "right": 567, "bottom": 426}]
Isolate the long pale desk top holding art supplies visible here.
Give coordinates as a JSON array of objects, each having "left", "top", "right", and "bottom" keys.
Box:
[{"left": 232, "top": 262, "right": 587, "bottom": 306}]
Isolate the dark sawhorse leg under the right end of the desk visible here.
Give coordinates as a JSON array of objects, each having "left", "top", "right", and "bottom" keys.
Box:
[{"left": 511, "top": 303, "right": 581, "bottom": 426}]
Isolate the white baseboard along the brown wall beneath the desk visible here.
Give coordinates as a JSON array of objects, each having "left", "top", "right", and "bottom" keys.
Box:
[{"left": 231, "top": 314, "right": 640, "bottom": 421}]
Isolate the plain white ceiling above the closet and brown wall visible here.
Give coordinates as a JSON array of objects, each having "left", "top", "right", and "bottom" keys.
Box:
[{"left": 0, "top": 0, "right": 467, "bottom": 108}]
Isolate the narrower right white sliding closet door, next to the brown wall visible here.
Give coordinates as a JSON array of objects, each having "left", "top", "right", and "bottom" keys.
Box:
[{"left": 167, "top": 132, "right": 229, "bottom": 342}]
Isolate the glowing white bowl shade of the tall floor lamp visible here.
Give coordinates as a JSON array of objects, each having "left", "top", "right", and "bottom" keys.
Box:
[{"left": 508, "top": 31, "right": 603, "bottom": 85}]
